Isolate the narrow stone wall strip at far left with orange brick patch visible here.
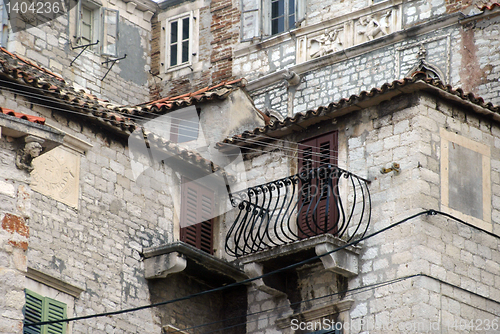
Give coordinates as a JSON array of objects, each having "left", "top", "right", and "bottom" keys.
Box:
[{"left": 0, "top": 135, "right": 31, "bottom": 334}]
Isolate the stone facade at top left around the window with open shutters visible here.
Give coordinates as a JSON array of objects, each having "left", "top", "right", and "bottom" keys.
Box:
[{"left": 2, "top": 0, "right": 157, "bottom": 105}]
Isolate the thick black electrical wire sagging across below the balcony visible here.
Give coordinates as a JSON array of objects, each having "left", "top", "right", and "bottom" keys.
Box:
[{"left": 25, "top": 210, "right": 500, "bottom": 327}]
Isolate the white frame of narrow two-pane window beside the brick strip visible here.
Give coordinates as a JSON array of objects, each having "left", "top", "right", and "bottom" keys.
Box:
[{"left": 164, "top": 11, "right": 194, "bottom": 72}]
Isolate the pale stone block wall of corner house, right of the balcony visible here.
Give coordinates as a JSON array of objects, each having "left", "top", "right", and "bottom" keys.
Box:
[{"left": 348, "top": 95, "right": 500, "bottom": 332}]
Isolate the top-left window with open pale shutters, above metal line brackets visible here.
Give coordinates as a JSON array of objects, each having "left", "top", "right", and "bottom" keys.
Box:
[{"left": 75, "top": 1, "right": 119, "bottom": 57}]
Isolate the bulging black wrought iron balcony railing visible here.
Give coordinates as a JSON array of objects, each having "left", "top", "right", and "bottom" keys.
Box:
[{"left": 225, "top": 166, "right": 371, "bottom": 257}]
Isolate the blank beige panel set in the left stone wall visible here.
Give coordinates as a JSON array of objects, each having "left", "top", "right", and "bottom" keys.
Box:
[{"left": 31, "top": 147, "right": 80, "bottom": 208}]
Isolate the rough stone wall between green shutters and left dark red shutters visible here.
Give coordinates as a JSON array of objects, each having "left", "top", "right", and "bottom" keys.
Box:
[{"left": 22, "top": 103, "right": 180, "bottom": 333}]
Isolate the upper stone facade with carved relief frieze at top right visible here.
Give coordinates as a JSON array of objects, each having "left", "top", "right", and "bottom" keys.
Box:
[{"left": 233, "top": 1, "right": 499, "bottom": 116}]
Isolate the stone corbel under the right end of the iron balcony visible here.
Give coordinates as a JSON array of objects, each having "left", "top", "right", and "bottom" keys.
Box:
[{"left": 314, "top": 243, "right": 359, "bottom": 277}]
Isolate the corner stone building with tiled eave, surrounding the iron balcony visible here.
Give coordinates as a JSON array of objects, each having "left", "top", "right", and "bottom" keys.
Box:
[{"left": 220, "top": 77, "right": 499, "bottom": 333}]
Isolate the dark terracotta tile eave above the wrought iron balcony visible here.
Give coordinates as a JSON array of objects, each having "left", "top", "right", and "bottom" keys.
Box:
[{"left": 216, "top": 72, "right": 500, "bottom": 149}]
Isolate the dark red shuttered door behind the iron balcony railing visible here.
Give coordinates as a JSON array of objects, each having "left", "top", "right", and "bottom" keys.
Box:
[{"left": 297, "top": 131, "right": 338, "bottom": 238}]
